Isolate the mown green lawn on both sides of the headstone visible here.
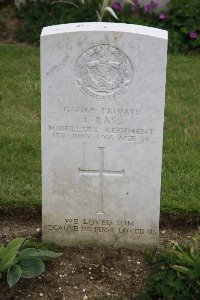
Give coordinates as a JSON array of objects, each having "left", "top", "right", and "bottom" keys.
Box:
[{"left": 0, "top": 45, "right": 200, "bottom": 215}]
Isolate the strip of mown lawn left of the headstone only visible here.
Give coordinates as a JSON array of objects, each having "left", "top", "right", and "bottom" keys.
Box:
[{"left": 0, "top": 45, "right": 41, "bottom": 206}]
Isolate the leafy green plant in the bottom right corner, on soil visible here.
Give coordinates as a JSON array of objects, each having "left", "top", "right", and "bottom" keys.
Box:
[{"left": 136, "top": 230, "right": 200, "bottom": 300}]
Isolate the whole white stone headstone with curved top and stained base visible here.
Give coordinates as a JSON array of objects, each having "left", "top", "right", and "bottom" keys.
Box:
[{"left": 41, "top": 23, "right": 167, "bottom": 247}]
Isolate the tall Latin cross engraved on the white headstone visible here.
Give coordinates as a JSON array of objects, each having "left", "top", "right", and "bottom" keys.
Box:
[{"left": 78, "top": 147, "right": 124, "bottom": 215}]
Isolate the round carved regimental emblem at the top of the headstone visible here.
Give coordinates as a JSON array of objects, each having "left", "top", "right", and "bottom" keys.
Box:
[{"left": 76, "top": 45, "right": 133, "bottom": 100}]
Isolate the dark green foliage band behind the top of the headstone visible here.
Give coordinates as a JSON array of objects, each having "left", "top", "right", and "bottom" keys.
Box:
[{"left": 14, "top": 0, "right": 200, "bottom": 53}]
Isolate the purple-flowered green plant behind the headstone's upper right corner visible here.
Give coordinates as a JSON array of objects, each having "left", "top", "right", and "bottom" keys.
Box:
[{"left": 112, "top": 0, "right": 200, "bottom": 52}]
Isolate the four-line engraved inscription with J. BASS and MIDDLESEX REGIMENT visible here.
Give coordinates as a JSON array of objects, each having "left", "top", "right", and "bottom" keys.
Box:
[{"left": 48, "top": 105, "right": 155, "bottom": 144}]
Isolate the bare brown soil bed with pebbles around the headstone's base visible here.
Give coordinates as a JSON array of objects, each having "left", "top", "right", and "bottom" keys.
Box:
[{"left": 0, "top": 212, "right": 197, "bottom": 300}]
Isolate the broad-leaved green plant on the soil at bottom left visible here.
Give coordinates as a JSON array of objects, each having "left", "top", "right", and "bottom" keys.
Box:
[{"left": 0, "top": 237, "right": 62, "bottom": 287}]
